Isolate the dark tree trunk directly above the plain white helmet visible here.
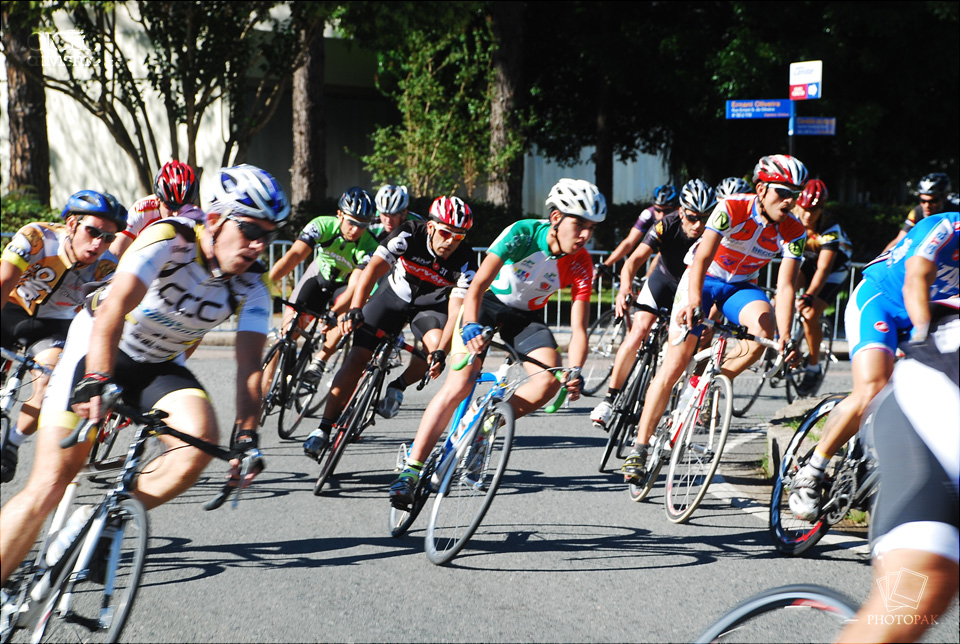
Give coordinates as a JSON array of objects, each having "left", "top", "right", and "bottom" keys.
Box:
[{"left": 487, "top": 1, "right": 525, "bottom": 216}]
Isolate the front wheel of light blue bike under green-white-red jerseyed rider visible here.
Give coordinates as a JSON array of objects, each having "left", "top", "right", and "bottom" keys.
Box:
[{"left": 425, "top": 402, "right": 514, "bottom": 565}]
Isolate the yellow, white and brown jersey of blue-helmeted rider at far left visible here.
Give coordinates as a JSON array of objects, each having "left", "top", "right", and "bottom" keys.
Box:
[{"left": 3, "top": 222, "right": 117, "bottom": 320}]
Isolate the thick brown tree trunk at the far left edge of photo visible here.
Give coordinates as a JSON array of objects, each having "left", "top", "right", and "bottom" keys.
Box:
[{"left": 2, "top": 3, "right": 50, "bottom": 205}]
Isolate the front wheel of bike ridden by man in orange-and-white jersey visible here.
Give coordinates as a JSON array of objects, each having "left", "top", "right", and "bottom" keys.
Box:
[{"left": 664, "top": 374, "right": 733, "bottom": 523}]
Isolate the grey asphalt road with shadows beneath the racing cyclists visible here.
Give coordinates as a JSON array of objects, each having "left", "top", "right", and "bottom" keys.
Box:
[{"left": 2, "top": 348, "right": 958, "bottom": 642}]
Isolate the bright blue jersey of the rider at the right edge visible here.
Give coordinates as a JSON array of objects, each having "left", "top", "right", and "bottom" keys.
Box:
[{"left": 863, "top": 212, "right": 960, "bottom": 310}]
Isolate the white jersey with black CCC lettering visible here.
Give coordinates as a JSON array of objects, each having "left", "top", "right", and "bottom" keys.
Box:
[{"left": 87, "top": 217, "right": 271, "bottom": 362}]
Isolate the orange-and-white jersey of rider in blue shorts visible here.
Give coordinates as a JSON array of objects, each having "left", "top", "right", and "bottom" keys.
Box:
[{"left": 706, "top": 195, "right": 807, "bottom": 282}]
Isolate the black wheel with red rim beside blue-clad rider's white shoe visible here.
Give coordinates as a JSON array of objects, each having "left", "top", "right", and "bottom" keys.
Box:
[{"left": 770, "top": 394, "right": 846, "bottom": 556}]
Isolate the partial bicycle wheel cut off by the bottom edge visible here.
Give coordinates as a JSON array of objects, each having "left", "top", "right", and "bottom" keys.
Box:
[{"left": 694, "top": 584, "right": 857, "bottom": 644}]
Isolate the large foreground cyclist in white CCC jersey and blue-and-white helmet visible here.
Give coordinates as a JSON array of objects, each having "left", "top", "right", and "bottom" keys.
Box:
[{"left": 0, "top": 165, "right": 290, "bottom": 580}]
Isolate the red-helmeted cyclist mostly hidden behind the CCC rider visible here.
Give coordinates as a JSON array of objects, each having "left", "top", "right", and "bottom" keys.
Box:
[{"left": 110, "top": 160, "right": 205, "bottom": 257}]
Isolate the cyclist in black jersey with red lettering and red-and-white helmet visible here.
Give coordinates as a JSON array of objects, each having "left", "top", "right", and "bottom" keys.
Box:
[{"left": 303, "top": 197, "right": 477, "bottom": 458}]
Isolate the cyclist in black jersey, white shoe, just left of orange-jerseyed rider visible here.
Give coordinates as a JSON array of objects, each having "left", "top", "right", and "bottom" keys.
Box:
[{"left": 590, "top": 179, "right": 717, "bottom": 429}]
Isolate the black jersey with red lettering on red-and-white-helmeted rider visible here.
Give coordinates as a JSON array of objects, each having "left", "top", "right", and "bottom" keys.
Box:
[{"left": 374, "top": 220, "right": 477, "bottom": 306}]
